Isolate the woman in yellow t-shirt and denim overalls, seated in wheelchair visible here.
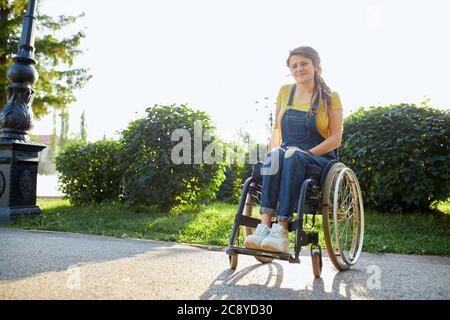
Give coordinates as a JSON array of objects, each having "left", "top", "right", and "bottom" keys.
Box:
[{"left": 244, "top": 46, "right": 343, "bottom": 252}]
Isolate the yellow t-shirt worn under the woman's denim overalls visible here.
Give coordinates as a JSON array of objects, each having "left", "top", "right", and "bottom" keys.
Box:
[{"left": 277, "top": 84, "right": 343, "bottom": 139}]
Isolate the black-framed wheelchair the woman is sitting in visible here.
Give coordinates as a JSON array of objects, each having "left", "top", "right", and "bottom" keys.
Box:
[{"left": 226, "top": 160, "right": 364, "bottom": 277}]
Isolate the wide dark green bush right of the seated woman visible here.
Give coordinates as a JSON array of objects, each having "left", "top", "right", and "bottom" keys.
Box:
[{"left": 340, "top": 104, "right": 450, "bottom": 212}]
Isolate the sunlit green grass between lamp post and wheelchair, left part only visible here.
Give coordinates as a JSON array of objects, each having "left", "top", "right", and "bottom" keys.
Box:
[{"left": 2, "top": 199, "right": 241, "bottom": 246}]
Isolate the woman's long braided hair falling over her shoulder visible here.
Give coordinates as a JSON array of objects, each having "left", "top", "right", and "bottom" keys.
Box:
[{"left": 286, "top": 46, "right": 331, "bottom": 114}]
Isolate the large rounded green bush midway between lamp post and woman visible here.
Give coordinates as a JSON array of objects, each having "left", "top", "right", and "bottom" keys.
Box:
[{"left": 121, "top": 105, "right": 225, "bottom": 210}]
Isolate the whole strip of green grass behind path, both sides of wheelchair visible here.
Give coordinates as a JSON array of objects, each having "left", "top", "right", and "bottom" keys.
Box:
[{"left": 2, "top": 199, "right": 450, "bottom": 256}]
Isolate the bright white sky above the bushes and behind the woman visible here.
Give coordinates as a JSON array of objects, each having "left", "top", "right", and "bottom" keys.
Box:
[{"left": 32, "top": 0, "right": 450, "bottom": 141}]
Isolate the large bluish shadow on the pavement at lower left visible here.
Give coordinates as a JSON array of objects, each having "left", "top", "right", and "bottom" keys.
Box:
[{"left": 0, "top": 228, "right": 197, "bottom": 280}]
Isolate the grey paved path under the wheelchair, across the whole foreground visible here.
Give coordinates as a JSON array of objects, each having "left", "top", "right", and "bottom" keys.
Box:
[{"left": 0, "top": 229, "right": 450, "bottom": 299}]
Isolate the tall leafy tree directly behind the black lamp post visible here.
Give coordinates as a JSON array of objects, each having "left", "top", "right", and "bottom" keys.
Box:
[{"left": 0, "top": 0, "right": 91, "bottom": 119}]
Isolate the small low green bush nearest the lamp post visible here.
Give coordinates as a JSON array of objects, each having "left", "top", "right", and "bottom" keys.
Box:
[{"left": 55, "top": 140, "right": 121, "bottom": 204}]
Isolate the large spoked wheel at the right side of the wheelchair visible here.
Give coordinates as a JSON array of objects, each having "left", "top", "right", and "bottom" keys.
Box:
[{"left": 322, "top": 162, "right": 364, "bottom": 270}]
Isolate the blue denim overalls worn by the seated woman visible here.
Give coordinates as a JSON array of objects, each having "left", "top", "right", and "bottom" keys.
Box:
[{"left": 260, "top": 84, "right": 336, "bottom": 222}]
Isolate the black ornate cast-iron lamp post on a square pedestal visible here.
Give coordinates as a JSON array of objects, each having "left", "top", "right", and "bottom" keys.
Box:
[{"left": 0, "top": 0, "right": 46, "bottom": 221}]
